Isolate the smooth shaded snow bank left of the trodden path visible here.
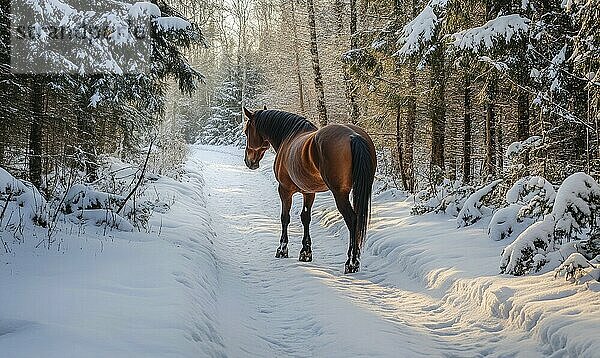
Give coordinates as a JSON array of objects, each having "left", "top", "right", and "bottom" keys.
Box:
[{"left": 0, "top": 158, "right": 222, "bottom": 358}]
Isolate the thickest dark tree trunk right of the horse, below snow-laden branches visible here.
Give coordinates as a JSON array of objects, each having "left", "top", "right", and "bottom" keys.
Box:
[{"left": 429, "top": 45, "right": 446, "bottom": 170}]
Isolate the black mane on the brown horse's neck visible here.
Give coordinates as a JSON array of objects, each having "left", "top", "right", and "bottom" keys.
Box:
[{"left": 254, "top": 109, "right": 317, "bottom": 150}]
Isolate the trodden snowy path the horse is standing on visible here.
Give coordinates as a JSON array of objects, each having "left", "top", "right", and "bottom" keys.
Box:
[{"left": 193, "top": 147, "right": 541, "bottom": 357}]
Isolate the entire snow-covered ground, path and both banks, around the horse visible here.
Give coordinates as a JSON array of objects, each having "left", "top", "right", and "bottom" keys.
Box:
[{"left": 0, "top": 146, "right": 600, "bottom": 357}]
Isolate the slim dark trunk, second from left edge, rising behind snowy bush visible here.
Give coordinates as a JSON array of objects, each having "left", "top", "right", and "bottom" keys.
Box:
[{"left": 29, "top": 76, "right": 44, "bottom": 189}]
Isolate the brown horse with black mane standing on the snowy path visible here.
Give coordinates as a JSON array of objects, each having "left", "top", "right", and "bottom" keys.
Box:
[{"left": 244, "top": 107, "right": 377, "bottom": 273}]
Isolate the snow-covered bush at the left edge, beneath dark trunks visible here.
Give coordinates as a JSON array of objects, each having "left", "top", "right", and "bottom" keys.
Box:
[{"left": 0, "top": 168, "right": 48, "bottom": 226}]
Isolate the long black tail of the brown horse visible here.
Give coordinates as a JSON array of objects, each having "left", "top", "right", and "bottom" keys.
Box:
[{"left": 350, "top": 135, "right": 375, "bottom": 248}]
